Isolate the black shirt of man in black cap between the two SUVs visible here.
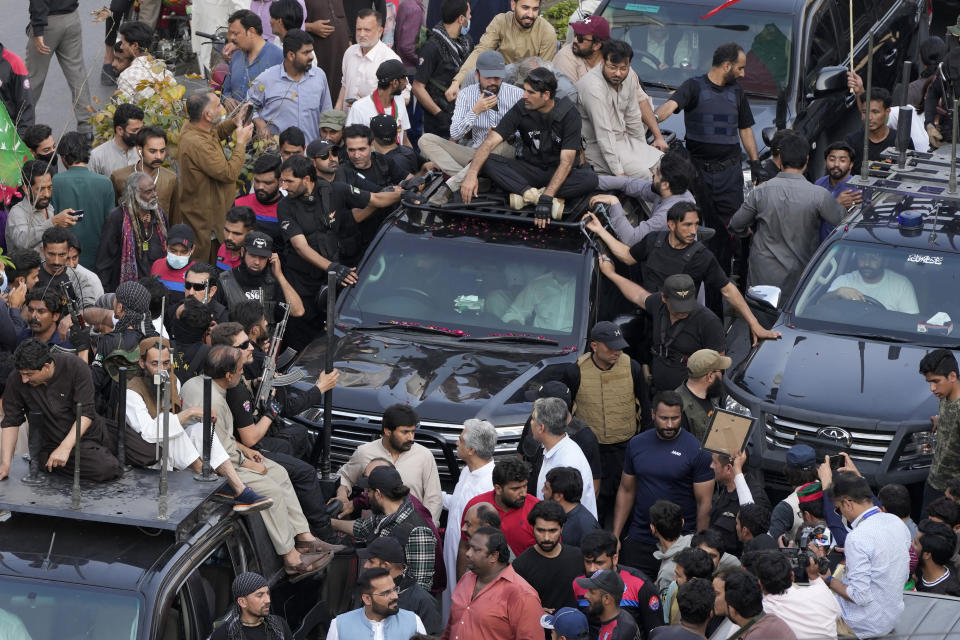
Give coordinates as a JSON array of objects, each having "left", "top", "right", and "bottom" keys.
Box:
[{"left": 644, "top": 293, "right": 725, "bottom": 391}]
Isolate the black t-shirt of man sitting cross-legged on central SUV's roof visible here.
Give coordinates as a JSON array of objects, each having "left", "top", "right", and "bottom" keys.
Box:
[{"left": 494, "top": 98, "right": 581, "bottom": 169}]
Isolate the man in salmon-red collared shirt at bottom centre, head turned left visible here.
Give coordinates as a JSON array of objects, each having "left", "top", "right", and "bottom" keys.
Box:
[{"left": 443, "top": 527, "right": 543, "bottom": 640}]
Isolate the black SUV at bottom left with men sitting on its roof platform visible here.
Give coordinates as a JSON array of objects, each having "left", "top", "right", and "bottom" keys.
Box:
[{"left": 0, "top": 457, "right": 342, "bottom": 640}]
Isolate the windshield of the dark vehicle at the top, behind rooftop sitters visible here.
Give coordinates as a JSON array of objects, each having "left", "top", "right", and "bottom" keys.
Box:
[{"left": 603, "top": 0, "right": 793, "bottom": 97}]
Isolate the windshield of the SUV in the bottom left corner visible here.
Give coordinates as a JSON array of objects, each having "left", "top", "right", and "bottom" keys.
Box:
[{"left": 0, "top": 576, "right": 140, "bottom": 640}]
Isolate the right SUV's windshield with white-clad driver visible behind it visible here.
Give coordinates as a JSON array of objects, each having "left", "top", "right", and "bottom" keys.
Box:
[{"left": 792, "top": 240, "right": 960, "bottom": 346}]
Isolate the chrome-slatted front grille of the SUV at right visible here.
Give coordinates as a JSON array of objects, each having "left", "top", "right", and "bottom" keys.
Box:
[{"left": 764, "top": 414, "right": 895, "bottom": 463}]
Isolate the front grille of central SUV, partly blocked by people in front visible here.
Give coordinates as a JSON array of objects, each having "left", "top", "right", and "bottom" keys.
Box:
[{"left": 300, "top": 407, "right": 519, "bottom": 487}]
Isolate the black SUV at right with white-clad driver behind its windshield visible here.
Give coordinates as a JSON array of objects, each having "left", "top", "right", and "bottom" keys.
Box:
[{"left": 725, "top": 152, "right": 960, "bottom": 496}]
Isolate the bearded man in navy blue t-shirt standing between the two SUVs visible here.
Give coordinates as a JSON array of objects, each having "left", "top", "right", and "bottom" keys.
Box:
[{"left": 613, "top": 391, "right": 714, "bottom": 575}]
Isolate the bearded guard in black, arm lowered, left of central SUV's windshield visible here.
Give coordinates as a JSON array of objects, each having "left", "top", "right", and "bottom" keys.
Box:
[{"left": 277, "top": 155, "right": 370, "bottom": 351}]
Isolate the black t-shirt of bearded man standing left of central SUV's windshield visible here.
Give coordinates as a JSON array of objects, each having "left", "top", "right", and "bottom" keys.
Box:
[{"left": 277, "top": 182, "right": 370, "bottom": 288}]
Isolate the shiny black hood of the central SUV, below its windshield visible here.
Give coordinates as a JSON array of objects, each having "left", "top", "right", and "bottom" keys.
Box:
[{"left": 298, "top": 331, "right": 575, "bottom": 424}]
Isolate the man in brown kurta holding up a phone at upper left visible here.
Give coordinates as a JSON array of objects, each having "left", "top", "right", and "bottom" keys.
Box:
[{"left": 177, "top": 92, "right": 253, "bottom": 264}]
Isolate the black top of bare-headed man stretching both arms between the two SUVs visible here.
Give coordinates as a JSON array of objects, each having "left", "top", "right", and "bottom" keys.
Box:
[{"left": 630, "top": 231, "right": 730, "bottom": 293}]
